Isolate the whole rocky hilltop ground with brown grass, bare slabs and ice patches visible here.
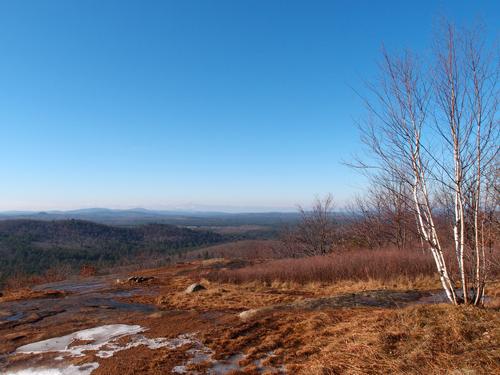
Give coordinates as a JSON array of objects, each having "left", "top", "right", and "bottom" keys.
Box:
[{"left": 0, "top": 261, "right": 500, "bottom": 375}]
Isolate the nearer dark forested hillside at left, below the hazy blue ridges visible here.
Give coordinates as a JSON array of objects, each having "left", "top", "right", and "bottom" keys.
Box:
[{"left": 0, "top": 220, "right": 224, "bottom": 283}]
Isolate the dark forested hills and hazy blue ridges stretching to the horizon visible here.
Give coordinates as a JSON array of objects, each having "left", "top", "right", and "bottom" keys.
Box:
[{"left": 0, "top": 208, "right": 352, "bottom": 286}]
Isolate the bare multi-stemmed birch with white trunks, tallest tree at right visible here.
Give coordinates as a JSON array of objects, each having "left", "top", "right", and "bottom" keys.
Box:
[{"left": 358, "top": 25, "right": 499, "bottom": 305}]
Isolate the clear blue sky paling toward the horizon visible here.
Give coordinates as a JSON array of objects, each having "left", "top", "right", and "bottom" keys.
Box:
[{"left": 0, "top": 0, "right": 500, "bottom": 210}]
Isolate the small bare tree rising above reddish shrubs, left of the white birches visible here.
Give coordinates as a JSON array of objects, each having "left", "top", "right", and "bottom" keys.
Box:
[{"left": 282, "top": 194, "right": 335, "bottom": 256}]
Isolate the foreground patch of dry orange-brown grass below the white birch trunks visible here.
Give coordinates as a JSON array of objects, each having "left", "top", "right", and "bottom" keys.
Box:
[{"left": 201, "top": 305, "right": 500, "bottom": 375}]
